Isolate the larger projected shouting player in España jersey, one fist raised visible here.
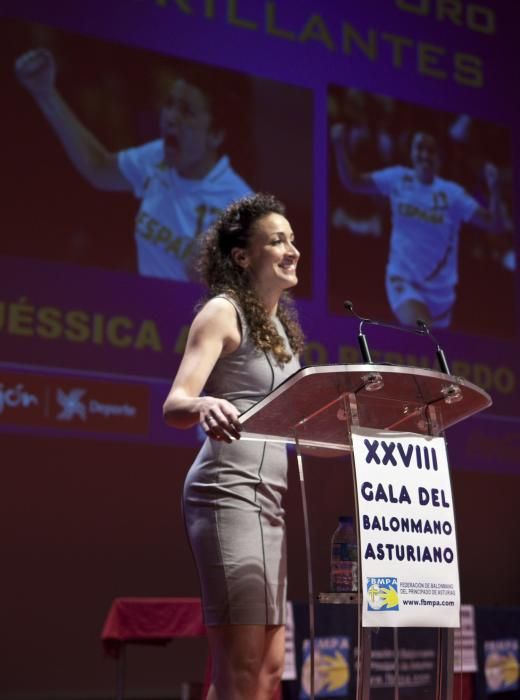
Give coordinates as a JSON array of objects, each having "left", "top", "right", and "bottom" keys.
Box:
[{"left": 15, "top": 49, "right": 250, "bottom": 281}]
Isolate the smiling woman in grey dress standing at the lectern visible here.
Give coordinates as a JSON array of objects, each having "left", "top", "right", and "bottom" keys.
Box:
[{"left": 164, "top": 194, "right": 303, "bottom": 700}]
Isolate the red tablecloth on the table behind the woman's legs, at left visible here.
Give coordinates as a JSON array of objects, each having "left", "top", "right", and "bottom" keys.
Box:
[{"left": 101, "top": 597, "right": 206, "bottom": 657}]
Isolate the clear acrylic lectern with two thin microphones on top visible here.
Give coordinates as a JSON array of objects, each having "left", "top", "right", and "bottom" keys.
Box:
[{"left": 240, "top": 364, "right": 491, "bottom": 700}]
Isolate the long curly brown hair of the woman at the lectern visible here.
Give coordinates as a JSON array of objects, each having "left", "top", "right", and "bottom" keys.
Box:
[{"left": 197, "top": 193, "right": 304, "bottom": 364}]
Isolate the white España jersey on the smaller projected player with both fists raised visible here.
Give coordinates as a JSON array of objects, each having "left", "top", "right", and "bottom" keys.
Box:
[{"left": 372, "top": 165, "right": 479, "bottom": 286}]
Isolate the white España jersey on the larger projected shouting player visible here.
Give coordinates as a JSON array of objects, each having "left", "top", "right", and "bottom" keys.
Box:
[{"left": 118, "top": 140, "right": 251, "bottom": 281}]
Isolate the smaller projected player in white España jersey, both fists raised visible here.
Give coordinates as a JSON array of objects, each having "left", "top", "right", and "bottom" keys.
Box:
[{"left": 331, "top": 124, "right": 502, "bottom": 328}]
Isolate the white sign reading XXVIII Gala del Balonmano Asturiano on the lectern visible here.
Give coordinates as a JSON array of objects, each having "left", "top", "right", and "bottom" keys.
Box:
[{"left": 352, "top": 428, "right": 460, "bottom": 627}]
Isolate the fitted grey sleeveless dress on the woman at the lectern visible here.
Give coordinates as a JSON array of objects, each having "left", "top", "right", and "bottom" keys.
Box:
[{"left": 183, "top": 297, "right": 299, "bottom": 625}]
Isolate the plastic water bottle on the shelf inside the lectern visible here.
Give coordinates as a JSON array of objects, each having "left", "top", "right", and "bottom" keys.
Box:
[{"left": 330, "top": 515, "right": 358, "bottom": 593}]
